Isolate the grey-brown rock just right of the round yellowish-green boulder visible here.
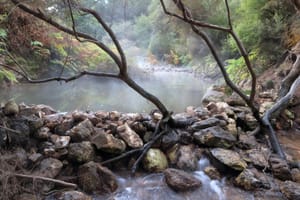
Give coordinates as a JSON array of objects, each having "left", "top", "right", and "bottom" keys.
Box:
[{"left": 176, "top": 144, "right": 199, "bottom": 171}]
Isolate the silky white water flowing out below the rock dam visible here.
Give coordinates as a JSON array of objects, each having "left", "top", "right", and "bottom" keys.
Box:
[{"left": 93, "top": 158, "right": 254, "bottom": 200}]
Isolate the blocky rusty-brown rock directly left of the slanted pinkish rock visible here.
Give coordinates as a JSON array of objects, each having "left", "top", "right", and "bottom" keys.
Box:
[{"left": 91, "top": 129, "right": 126, "bottom": 154}]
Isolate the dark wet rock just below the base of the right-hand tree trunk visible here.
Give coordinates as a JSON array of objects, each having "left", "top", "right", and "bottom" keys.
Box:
[{"left": 269, "top": 154, "right": 292, "bottom": 181}]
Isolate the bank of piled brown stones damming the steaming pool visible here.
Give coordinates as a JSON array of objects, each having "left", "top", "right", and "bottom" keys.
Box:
[{"left": 0, "top": 85, "right": 300, "bottom": 199}]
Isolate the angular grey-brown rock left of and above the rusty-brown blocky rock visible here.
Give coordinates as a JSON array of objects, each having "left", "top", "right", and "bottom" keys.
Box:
[{"left": 67, "top": 119, "right": 94, "bottom": 142}]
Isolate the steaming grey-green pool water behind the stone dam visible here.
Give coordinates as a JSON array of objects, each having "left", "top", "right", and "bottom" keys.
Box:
[{"left": 0, "top": 61, "right": 212, "bottom": 112}]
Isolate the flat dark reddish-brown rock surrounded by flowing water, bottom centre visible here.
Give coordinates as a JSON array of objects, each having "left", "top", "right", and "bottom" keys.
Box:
[{"left": 164, "top": 168, "right": 201, "bottom": 192}]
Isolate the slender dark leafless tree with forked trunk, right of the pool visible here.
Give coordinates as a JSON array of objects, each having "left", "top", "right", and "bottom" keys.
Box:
[{"left": 160, "top": 0, "right": 285, "bottom": 159}]
